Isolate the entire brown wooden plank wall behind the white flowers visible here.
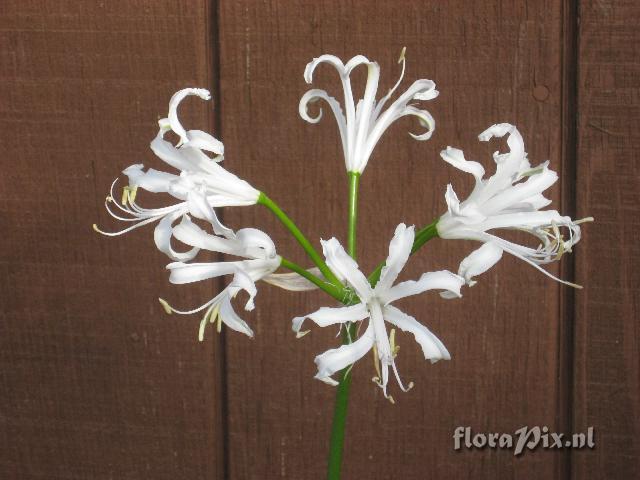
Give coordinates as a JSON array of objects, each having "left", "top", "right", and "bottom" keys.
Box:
[{"left": 0, "top": 0, "right": 640, "bottom": 480}]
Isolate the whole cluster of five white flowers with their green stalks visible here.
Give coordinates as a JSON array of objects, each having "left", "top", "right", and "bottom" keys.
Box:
[{"left": 94, "top": 50, "right": 592, "bottom": 401}]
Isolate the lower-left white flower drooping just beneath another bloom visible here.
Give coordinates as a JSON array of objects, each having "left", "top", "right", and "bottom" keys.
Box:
[{"left": 160, "top": 215, "right": 285, "bottom": 341}]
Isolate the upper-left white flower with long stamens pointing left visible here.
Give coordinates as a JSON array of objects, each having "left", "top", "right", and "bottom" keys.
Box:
[{"left": 94, "top": 88, "right": 260, "bottom": 261}]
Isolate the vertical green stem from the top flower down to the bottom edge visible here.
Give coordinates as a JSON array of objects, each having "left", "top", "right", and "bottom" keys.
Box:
[{"left": 327, "top": 172, "right": 360, "bottom": 480}]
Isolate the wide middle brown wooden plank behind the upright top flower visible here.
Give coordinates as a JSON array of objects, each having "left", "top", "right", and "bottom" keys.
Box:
[{"left": 220, "top": 1, "right": 565, "bottom": 479}]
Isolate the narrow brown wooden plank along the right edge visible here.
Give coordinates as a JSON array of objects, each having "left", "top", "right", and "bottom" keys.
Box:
[{"left": 572, "top": 1, "right": 640, "bottom": 479}]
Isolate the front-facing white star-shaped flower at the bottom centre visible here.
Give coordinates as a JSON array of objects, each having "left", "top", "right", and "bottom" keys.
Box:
[{"left": 293, "top": 224, "right": 464, "bottom": 398}]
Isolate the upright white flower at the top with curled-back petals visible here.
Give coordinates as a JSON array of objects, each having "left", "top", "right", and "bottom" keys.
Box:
[{"left": 299, "top": 49, "right": 438, "bottom": 173}]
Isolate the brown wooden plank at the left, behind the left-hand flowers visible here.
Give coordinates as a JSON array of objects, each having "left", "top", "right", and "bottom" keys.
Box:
[{"left": 0, "top": 0, "right": 223, "bottom": 480}]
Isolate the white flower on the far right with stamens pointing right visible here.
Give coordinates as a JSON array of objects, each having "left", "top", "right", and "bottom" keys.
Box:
[{"left": 437, "top": 123, "right": 593, "bottom": 288}]
